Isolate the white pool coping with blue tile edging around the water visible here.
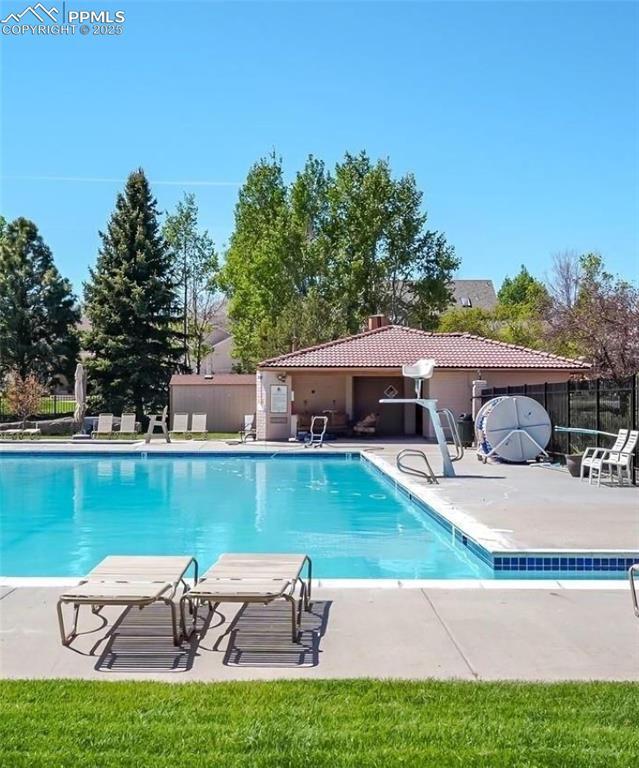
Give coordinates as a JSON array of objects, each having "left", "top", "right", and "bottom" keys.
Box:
[{"left": 0, "top": 442, "right": 639, "bottom": 588}]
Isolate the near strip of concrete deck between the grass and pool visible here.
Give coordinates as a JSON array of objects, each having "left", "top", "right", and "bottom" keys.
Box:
[{"left": 0, "top": 585, "right": 639, "bottom": 682}]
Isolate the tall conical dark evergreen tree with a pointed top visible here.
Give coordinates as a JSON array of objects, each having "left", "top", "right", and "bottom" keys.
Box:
[{"left": 85, "top": 169, "right": 182, "bottom": 420}]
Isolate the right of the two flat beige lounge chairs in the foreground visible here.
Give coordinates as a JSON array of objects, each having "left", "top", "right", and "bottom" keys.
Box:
[{"left": 180, "top": 554, "right": 312, "bottom": 643}]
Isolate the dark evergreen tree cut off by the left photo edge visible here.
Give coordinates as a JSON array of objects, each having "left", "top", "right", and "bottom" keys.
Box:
[{"left": 0, "top": 217, "right": 80, "bottom": 384}]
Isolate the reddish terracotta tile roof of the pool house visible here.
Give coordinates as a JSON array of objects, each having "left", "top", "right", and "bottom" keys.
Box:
[{"left": 260, "top": 325, "right": 590, "bottom": 370}]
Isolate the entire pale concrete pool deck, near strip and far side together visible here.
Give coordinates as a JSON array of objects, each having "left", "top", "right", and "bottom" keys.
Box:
[{"left": 0, "top": 441, "right": 639, "bottom": 681}]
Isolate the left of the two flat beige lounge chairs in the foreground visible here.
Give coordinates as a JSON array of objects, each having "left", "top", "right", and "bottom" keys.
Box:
[{"left": 57, "top": 555, "right": 198, "bottom": 645}]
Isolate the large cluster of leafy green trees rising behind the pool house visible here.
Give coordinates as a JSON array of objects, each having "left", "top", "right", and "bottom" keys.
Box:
[{"left": 222, "top": 152, "right": 459, "bottom": 370}]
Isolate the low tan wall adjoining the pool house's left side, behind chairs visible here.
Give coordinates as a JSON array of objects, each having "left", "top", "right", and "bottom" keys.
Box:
[{"left": 171, "top": 384, "right": 255, "bottom": 432}]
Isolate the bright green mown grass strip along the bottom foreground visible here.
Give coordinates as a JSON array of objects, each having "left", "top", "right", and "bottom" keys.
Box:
[{"left": 0, "top": 680, "right": 639, "bottom": 768}]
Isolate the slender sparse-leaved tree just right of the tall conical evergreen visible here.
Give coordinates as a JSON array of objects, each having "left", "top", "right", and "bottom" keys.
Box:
[{"left": 163, "top": 194, "right": 222, "bottom": 373}]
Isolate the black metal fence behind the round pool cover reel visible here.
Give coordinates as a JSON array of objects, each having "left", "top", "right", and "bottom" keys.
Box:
[{"left": 481, "top": 374, "right": 639, "bottom": 476}]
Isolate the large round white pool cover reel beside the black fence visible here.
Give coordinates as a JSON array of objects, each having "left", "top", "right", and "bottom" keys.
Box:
[{"left": 475, "top": 395, "right": 552, "bottom": 463}]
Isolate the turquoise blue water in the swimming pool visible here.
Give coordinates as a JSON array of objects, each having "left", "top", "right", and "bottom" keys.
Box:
[{"left": 0, "top": 456, "right": 491, "bottom": 579}]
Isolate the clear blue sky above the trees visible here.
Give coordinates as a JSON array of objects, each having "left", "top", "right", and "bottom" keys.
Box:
[{"left": 0, "top": 0, "right": 639, "bottom": 290}]
